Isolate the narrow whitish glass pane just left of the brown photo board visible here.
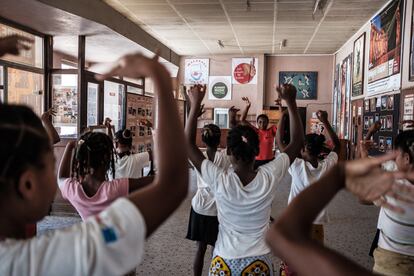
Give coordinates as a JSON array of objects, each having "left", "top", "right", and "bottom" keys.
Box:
[{"left": 104, "top": 81, "right": 125, "bottom": 131}]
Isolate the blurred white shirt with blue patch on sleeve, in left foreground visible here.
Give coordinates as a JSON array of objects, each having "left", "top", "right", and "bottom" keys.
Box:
[{"left": 0, "top": 199, "right": 146, "bottom": 276}]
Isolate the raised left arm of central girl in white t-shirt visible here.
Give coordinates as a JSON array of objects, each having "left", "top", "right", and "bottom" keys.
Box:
[{"left": 185, "top": 85, "right": 206, "bottom": 174}]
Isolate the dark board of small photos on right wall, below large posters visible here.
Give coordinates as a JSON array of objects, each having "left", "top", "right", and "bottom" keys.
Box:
[{"left": 363, "top": 94, "right": 400, "bottom": 155}]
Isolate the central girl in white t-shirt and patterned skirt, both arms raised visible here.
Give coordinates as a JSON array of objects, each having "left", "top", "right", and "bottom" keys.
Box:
[{"left": 186, "top": 85, "right": 303, "bottom": 275}]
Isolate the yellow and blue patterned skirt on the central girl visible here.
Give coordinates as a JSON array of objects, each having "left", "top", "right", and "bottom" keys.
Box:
[{"left": 208, "top": 254, "right": 274, "bottom": 276}]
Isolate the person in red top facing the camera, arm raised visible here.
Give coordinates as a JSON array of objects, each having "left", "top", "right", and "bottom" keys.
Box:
[{"left": 240, "top": 97, "right": 277, "bottom": 168}]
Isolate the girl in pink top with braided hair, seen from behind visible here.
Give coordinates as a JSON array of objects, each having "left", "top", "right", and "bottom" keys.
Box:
[{"left": 58, "top": 132, "right": 153, "bottom": 220}]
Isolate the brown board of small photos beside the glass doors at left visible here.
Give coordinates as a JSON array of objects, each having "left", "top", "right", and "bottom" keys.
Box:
[{"left": 126, "top": 93, "right": 154, "bottom": 153}]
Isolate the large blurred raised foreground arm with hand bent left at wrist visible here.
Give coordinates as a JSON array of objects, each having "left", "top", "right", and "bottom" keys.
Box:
[{"left": 100, "top": 54, "right": 188, "bottom": 237}]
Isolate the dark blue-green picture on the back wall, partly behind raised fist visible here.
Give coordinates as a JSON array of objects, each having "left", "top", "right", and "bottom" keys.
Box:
[{"left": 279, "top": 71, "right": 318, "bottom": 100}]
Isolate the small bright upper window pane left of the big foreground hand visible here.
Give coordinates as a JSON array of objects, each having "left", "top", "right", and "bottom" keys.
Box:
[{"left": 53, "top": 36, "right": 78, "bottom": 69}]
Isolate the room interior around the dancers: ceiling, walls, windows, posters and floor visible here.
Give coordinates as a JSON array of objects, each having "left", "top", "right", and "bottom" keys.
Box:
[{"left": 0, "top": 0, "right": 414, "bottom": 275}]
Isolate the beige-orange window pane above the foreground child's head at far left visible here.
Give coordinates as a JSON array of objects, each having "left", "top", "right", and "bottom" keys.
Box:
[{"left": 7, "top": 68, "right": 44, "bottom": 116}]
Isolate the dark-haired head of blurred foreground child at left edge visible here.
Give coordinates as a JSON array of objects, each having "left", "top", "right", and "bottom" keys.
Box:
[{"left": 0, "top": 104, "right": 52, "bottom": 195}]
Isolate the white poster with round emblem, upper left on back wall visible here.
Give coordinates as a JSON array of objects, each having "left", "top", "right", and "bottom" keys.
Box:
[{"left": 184, "top": 58, "right": 210, "bottom": 85}]
